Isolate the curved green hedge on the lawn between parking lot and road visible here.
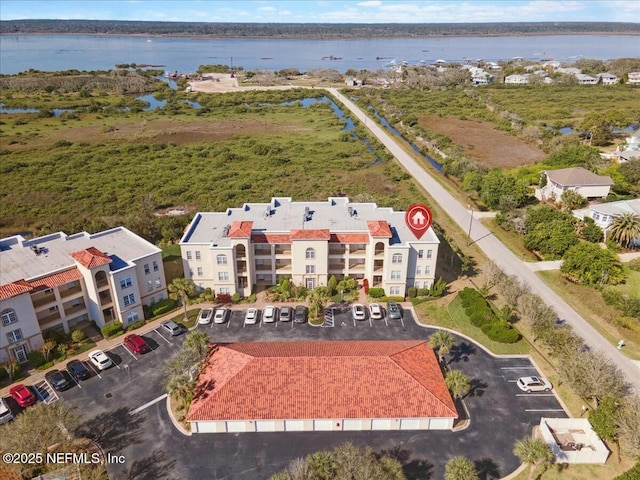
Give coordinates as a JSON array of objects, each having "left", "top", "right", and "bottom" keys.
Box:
[{"left": 458, "top": 287, "right": 520, "bottom": 343}]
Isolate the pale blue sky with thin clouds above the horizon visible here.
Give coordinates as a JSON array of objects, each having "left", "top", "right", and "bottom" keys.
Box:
[{"left": 0, "top": 0, "right": 640, "bottom": 23}]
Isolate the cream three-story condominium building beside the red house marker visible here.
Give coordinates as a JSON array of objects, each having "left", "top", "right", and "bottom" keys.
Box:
[{"left": 180, "top": 197, "right": 439, "bottom": 296}]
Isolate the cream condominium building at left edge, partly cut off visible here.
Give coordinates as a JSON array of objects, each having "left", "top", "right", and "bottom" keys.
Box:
[{"left": 0, "top": 227, "right": 167, "bottom": 362}]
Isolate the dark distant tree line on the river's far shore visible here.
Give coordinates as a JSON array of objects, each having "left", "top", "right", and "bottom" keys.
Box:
[{"left": 5, "top": 20, "right": 640, "bottom": 38}]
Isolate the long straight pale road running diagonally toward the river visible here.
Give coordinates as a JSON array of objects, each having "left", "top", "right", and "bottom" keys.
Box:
[{"left": 327, "top": 88, "right": 640, "bottom": 392}]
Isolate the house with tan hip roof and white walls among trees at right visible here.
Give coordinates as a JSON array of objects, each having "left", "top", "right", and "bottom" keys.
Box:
[{"left": 535, "top": 167, "right": 613, "bottom": 202}]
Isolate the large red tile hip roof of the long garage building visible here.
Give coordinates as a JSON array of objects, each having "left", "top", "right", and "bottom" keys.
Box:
[{"left": 187, "top": 341, "right": 458, "bottom": 421}]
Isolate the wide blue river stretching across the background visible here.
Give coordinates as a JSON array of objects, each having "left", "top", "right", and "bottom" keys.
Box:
[{"left": 0, "top": 35, "right": 640, "bottom": 74}]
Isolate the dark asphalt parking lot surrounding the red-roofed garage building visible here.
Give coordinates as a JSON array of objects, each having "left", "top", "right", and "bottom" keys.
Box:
[{"left": 38, "top": 310, "right": 566, "bottom": 479}]
